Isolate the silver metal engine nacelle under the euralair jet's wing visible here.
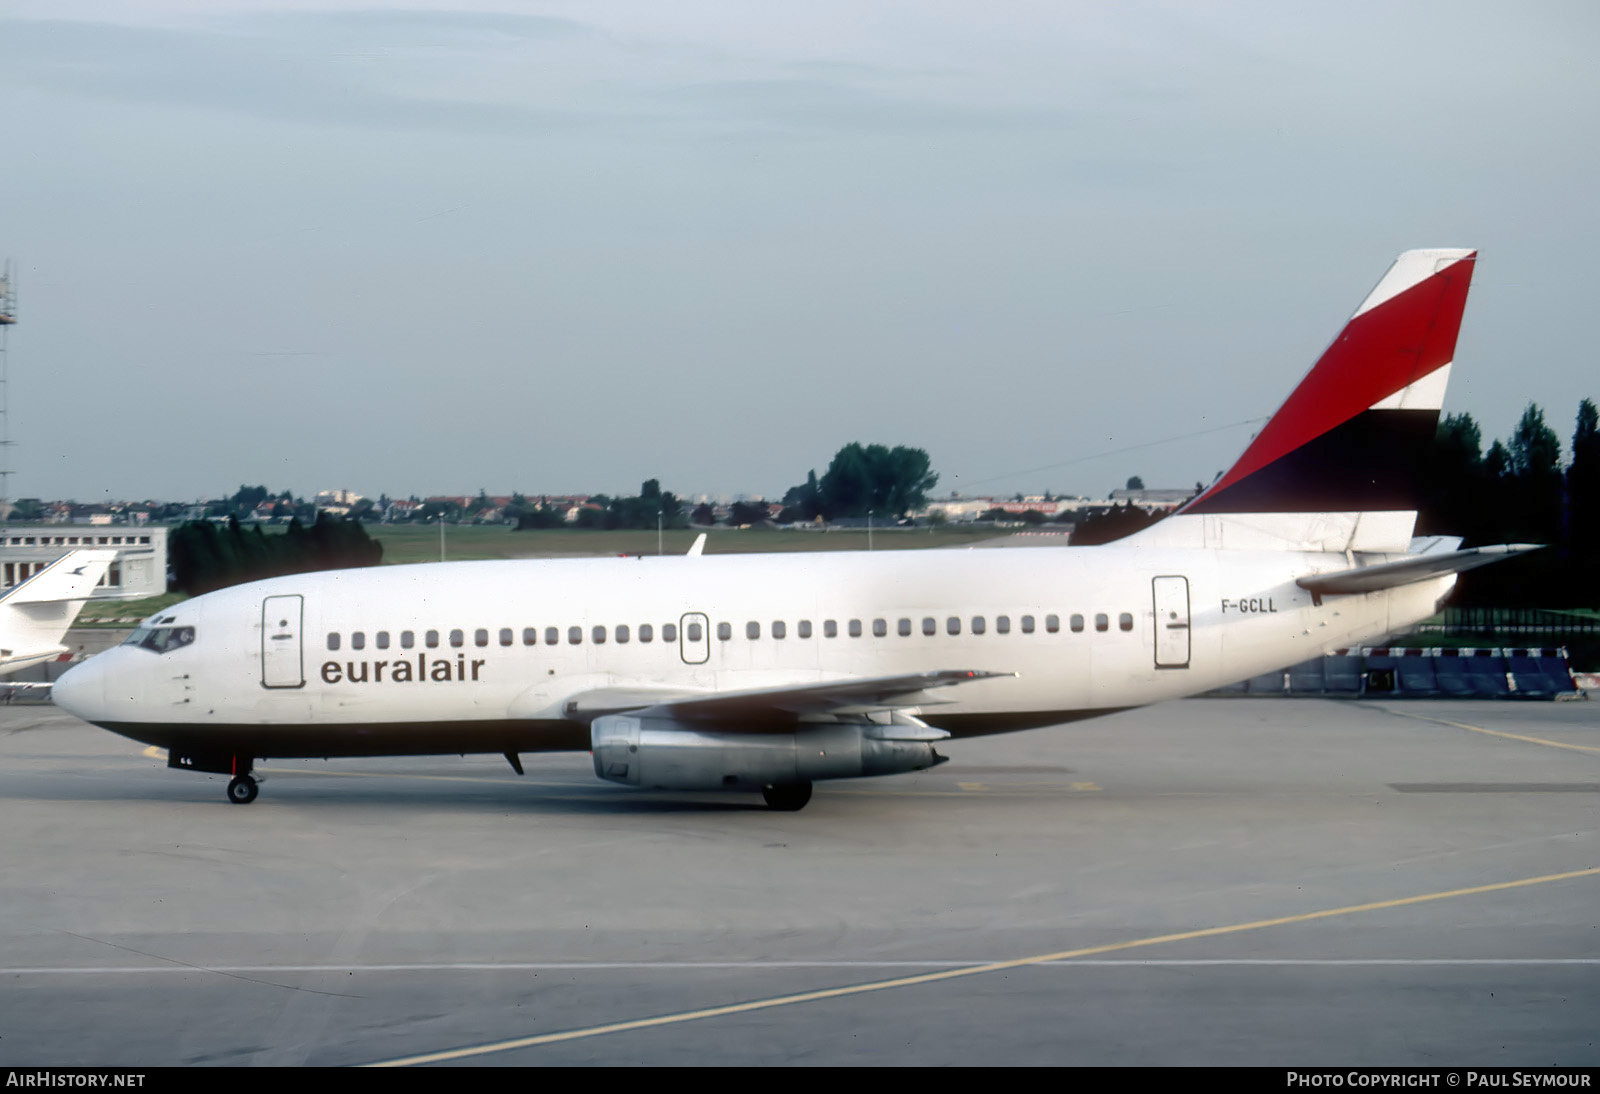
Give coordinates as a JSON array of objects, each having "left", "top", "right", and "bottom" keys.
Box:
[{"left": 589, "top": 715, "right": 946, "bottom": 790}]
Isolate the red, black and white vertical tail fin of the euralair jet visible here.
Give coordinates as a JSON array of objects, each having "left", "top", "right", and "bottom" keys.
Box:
[{"left": 1123, "top": 250, "right": 1477, "bottom": 552}]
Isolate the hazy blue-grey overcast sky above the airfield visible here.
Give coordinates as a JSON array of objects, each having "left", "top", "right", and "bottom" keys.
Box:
[{"left": 0, "top": 0, "right": 1600, "bottom": 501}]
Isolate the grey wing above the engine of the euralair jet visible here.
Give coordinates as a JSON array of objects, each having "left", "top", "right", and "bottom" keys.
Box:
[{"left": 565, "top": 669, "right": 1016, "bottom": 728}]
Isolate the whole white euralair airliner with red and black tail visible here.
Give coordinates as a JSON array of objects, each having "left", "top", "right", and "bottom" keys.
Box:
[{"left": 54, "top": 250, "right": 1515, "bottom": 809}]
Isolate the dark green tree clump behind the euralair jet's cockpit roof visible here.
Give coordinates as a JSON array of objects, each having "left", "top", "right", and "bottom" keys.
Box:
[{"left": 166, "top": 513, "right": 384, "bottom": 597}]
